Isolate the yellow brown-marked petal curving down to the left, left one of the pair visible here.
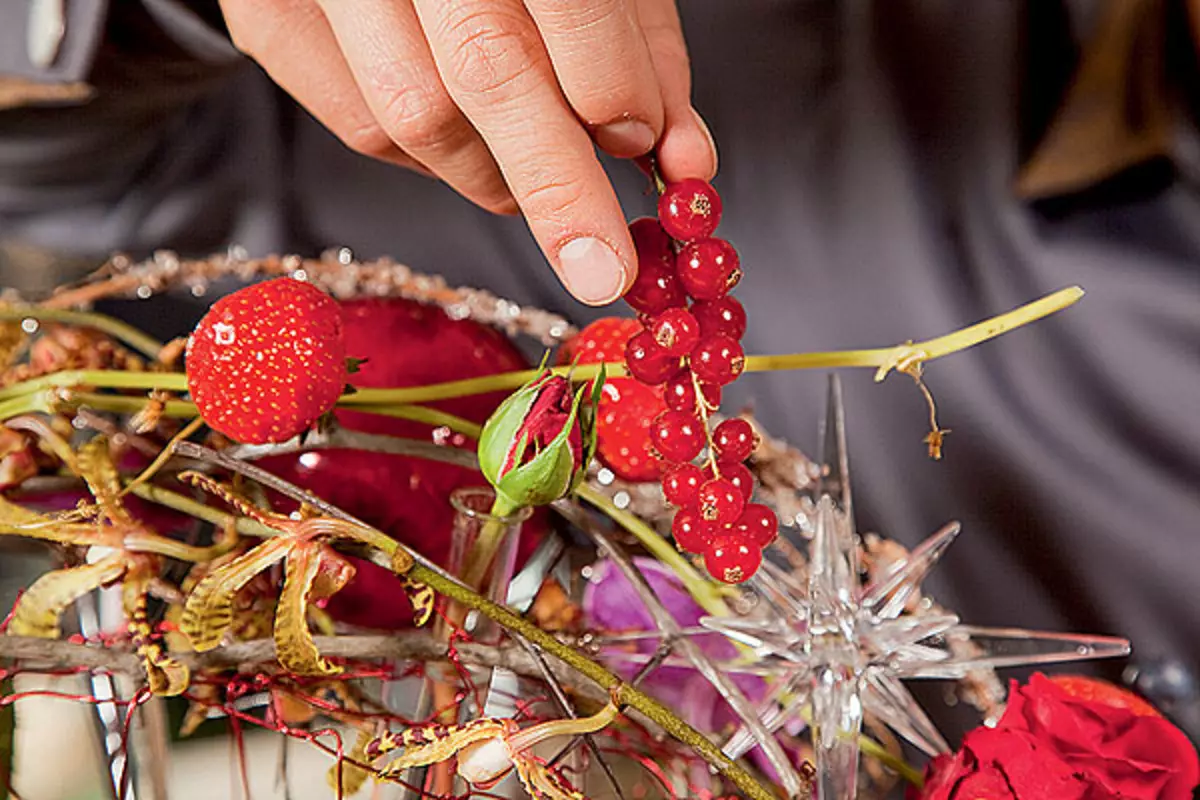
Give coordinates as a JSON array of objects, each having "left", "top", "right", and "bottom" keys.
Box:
[{"left": 179, "top": 536, "right": 295, "bottom": 652}]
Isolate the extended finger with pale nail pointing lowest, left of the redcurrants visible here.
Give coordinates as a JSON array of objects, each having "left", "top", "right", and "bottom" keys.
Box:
[{"left": 415, "top": 0, "right": 636, "bottom": 306}]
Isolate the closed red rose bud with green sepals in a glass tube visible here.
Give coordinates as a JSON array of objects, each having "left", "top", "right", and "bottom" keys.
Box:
[{"left": 479, "top": 371, "right": 604, "bottom": 509}]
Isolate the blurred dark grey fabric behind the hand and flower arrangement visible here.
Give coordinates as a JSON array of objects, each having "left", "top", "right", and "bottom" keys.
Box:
[{"left": 0, "top": 0, "right": 1200, "bottom": 736}]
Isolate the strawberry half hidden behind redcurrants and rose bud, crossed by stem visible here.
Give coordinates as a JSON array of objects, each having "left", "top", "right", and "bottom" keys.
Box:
[{"left": 562, "top": 317, "right": 667, "bottom": 481}]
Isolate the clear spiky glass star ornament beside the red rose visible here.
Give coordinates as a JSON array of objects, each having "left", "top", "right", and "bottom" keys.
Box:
[{"left": 701, "top": 378, "right": 1129, "bottom": 800}]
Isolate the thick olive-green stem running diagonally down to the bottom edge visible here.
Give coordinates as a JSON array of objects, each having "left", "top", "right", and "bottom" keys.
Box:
[{"left": 408, "top": 563, "right": 778, "bottom": 800}]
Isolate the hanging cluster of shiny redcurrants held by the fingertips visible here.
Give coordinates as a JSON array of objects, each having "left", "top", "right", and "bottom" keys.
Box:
[{"left": 625, "top": 179, "right": 779, "bottom": 583}]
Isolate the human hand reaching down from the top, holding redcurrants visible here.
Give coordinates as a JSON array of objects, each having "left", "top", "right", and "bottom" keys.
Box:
[{"left": 221, "top": 0, "right": 716, "bottom": 305}]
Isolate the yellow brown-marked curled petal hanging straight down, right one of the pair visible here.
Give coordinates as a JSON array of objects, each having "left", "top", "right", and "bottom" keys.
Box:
[{"left": 282, "top": 542, "right": 353, "bottom": 675}]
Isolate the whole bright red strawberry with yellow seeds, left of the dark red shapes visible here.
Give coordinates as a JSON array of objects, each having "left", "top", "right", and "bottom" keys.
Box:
[{"left": 187, "top": 278, "right": 347, "bottom": 444}]
